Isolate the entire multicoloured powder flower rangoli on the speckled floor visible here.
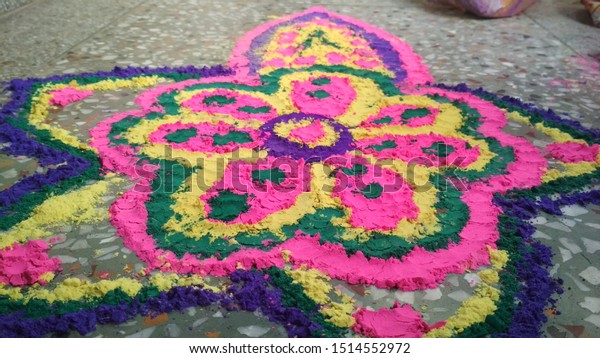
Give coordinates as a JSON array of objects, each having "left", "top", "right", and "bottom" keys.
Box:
[{"left": 0, "top": 8, "right": 600, "bottom": 337}]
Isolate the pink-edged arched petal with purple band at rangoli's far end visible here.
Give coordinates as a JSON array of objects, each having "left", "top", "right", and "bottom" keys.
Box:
[{"left": 229, "top": 7, "right": 432, "bottom": 87}]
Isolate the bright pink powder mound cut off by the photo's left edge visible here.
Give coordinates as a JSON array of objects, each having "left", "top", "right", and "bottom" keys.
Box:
[{"left": 0, "top": 240, "right": 61, "bottom": 286}]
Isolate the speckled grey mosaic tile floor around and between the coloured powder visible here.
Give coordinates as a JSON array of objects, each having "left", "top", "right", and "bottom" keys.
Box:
[{"left": 0, "top": 0, "right": 600, "bottom": 337}]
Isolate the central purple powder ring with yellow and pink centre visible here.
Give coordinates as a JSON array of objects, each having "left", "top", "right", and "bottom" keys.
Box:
[{"left": 260, "top": 113, "right": 353, "bottom": 163}]
